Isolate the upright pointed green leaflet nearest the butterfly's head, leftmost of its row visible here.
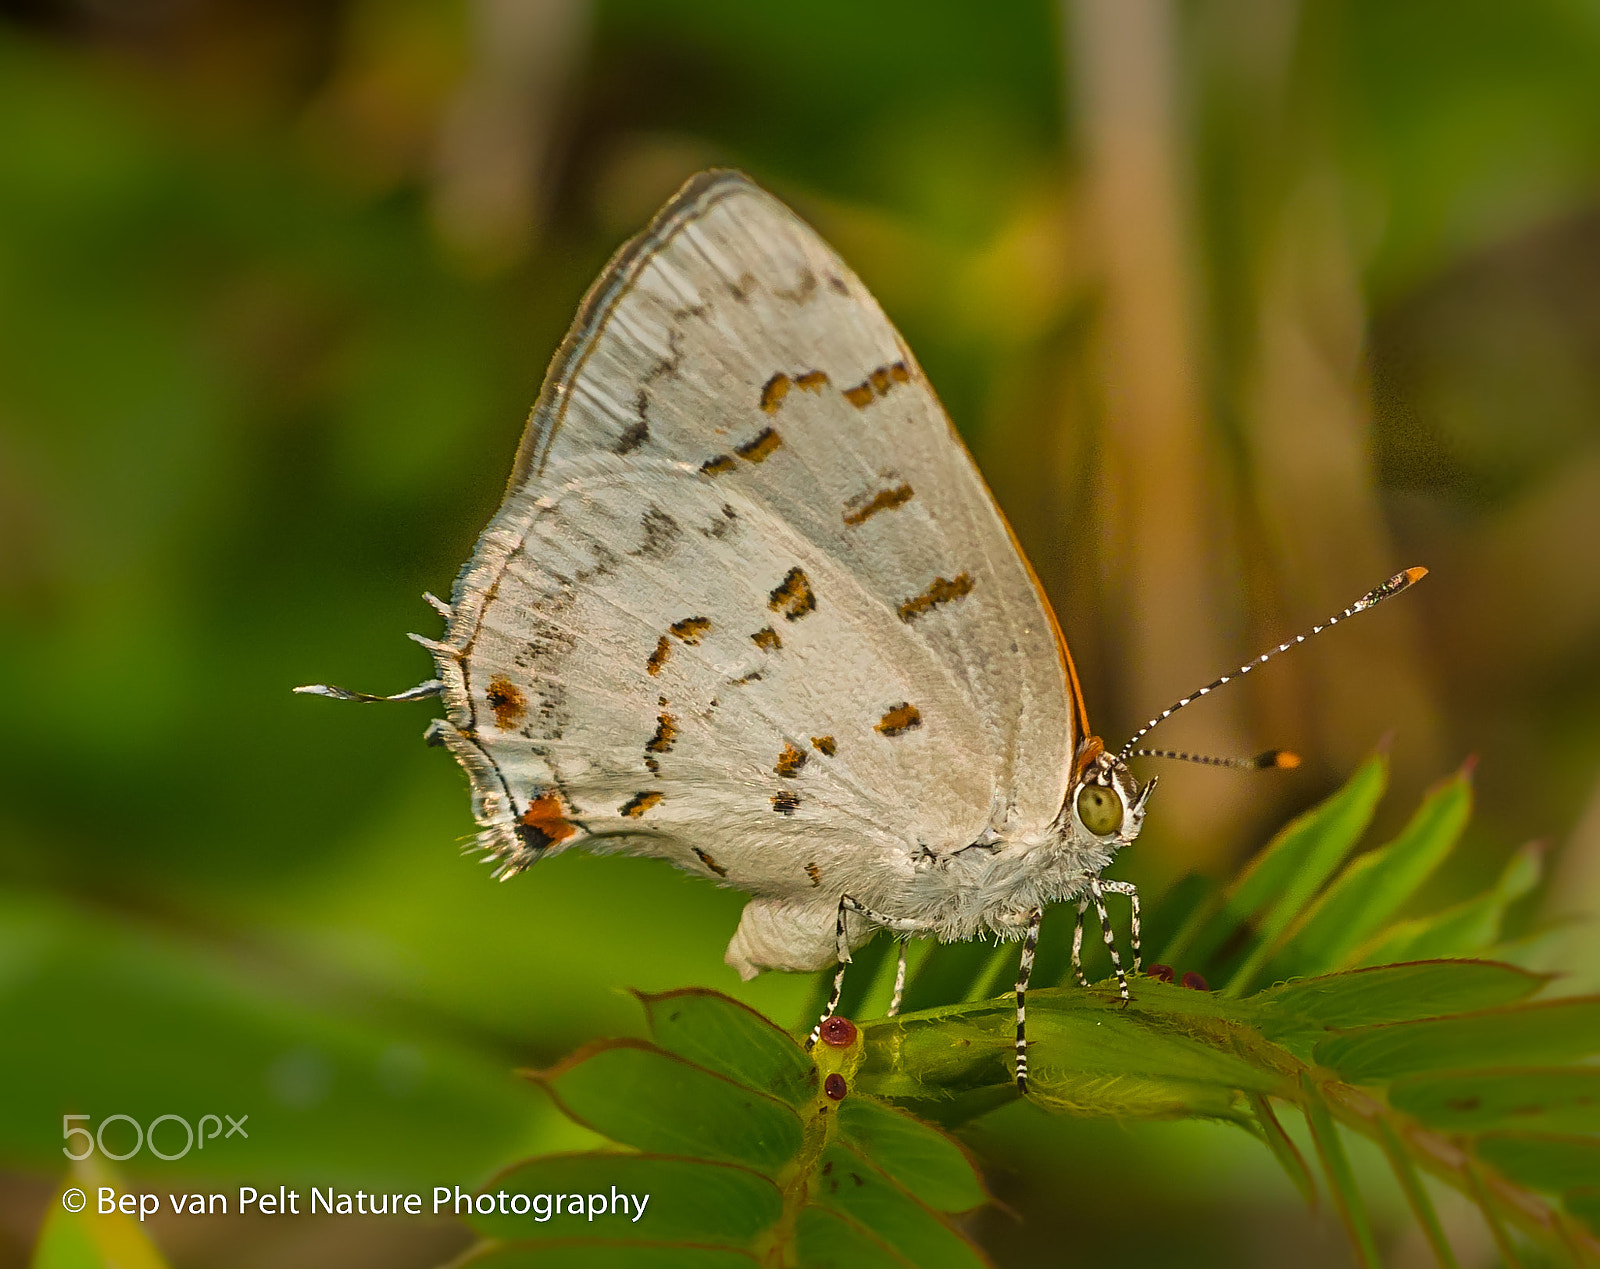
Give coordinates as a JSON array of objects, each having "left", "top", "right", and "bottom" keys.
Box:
[{"left": 1162, "top": 754, "right": 1389, "bottom": 965}]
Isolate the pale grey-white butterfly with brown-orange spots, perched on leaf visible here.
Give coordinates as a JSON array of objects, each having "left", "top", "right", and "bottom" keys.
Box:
[{"left": 298, "top": 171, "right": 1422, "bottom": 1091}]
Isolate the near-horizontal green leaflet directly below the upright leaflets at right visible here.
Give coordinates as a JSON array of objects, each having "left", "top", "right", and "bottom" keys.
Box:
[{"left": 1248, "top": 960, "right": 1550, "bottom": 1053}]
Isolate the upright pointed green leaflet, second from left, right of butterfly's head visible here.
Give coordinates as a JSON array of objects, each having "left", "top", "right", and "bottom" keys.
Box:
[{"left": 1264, "top": 770, "right": 1472, "bottom": 981}]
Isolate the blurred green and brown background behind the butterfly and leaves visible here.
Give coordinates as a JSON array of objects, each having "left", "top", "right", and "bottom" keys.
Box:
[{"left": 0, "top": 0, "right": 1600, "bottom": 1269}]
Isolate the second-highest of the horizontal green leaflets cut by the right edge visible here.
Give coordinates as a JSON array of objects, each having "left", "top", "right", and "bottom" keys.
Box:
[{"left": 1389, "top": 1067, "right": 1600, "bottom": 1133}]
